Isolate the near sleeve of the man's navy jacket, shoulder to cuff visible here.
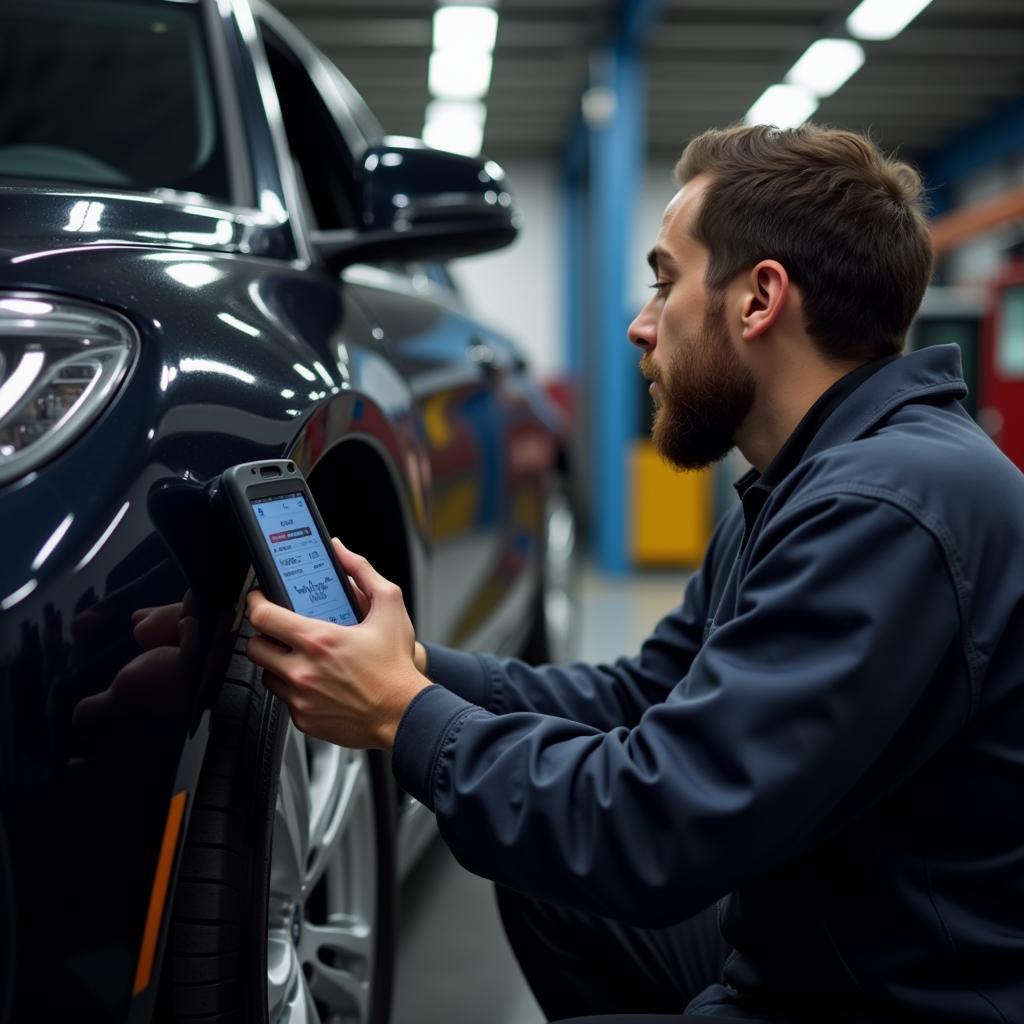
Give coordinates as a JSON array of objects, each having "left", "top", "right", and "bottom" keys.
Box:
[{"left": 393, "top": 494, "right": 959, "bottom": 927}]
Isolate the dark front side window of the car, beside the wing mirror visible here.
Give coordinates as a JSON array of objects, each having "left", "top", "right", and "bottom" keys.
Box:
[{"left": 260, "top": 24, "right": 355, "bottom": 230}]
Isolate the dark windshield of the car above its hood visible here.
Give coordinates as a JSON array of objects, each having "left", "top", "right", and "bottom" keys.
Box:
[{"left": 0, "top": 0, "right": 230, "bottom": 199}]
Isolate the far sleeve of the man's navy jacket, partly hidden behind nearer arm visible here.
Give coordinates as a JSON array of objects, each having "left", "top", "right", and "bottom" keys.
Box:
[{"left": 419, "top": 510, "right": 738, "bottom": 729}]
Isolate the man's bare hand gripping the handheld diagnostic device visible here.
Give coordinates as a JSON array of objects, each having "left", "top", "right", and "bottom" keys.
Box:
[{"left": 246, "top": 540, "right": 430, "bottom": 750}]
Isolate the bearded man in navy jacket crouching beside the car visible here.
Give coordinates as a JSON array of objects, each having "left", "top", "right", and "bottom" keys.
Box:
[{"left": 249, "top": 125, "right": 1024, "bottom": 1024}]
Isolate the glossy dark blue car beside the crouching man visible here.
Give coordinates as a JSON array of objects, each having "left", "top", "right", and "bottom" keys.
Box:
[{"left": 0, "top": 0, "right": 573, "bottom": 1024}]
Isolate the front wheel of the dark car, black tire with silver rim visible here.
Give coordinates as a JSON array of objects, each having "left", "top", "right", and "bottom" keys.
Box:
[{"left": 163, "top": 622, "right": 395, "bottom": 1024}]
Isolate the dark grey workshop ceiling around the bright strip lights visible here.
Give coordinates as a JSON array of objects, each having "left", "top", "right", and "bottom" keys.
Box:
[{"left": 275, "top": 0, "right": 1024, "bottom": 161}]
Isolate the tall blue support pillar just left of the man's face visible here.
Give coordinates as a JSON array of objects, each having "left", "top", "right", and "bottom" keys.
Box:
[{"left": 563, "top": 0, "right": 664, "bottom": 572}]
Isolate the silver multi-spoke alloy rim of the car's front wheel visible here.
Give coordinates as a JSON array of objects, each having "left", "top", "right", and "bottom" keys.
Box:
[{"left": 267, "top": 722, "right": 377, "bottom": 1024}]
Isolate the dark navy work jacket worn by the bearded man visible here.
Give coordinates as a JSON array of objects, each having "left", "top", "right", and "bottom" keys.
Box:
[{"left": 394, "top": 346, "right": 1024, "bottom": 1024}]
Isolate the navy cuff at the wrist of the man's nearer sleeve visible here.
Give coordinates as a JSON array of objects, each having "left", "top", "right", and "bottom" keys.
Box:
[{"left": 391, "top": 686, "right": 479, "bottom": 810}]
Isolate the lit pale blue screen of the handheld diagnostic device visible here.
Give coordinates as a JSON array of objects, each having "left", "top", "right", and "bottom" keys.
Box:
[{"left": 251, "top": 492, "right": 357, "bottom": 626}]
